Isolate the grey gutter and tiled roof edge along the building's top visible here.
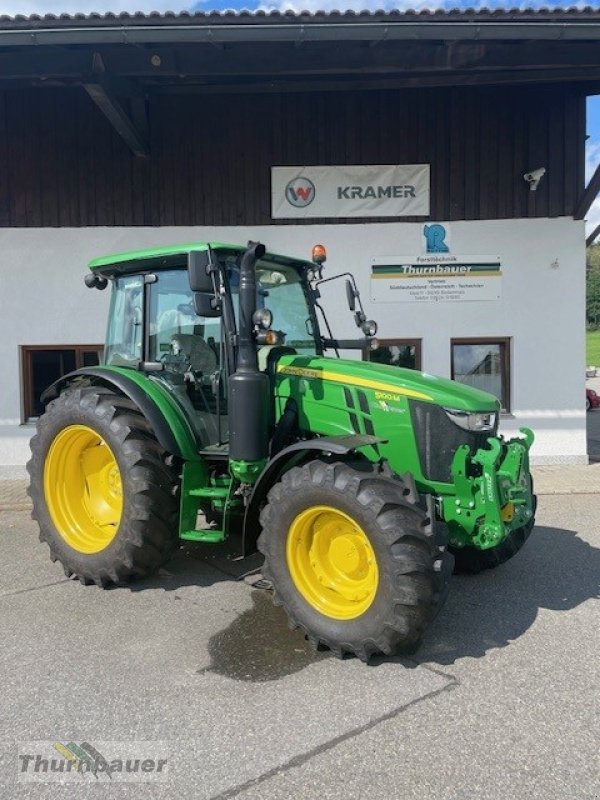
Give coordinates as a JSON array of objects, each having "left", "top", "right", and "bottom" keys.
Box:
[{"left": 0, "top": 8, "right": 600, "bottom": 47}]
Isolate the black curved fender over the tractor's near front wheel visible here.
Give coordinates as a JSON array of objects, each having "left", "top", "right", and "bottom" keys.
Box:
[{"left": 242, "top": 434, "right": 387, "bottom": 556}]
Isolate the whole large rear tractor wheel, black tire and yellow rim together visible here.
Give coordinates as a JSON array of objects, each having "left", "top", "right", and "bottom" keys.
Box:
[{"left": 27, "top": 386, "right": 179, "bottom": 587}]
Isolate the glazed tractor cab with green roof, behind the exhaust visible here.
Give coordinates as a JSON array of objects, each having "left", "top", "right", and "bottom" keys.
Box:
[{"left": 91, "top": 244, "right": 321, "bottom": 452}]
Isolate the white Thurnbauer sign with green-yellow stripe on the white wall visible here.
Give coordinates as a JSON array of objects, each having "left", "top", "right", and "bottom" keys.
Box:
[{"left": 371, "top": 253, "right": 502, "bottom": 303}]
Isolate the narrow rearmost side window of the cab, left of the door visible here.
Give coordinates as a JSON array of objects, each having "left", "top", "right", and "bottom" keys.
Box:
[{"left": 104, "top": 275, "right": 144, "bottom": 367}]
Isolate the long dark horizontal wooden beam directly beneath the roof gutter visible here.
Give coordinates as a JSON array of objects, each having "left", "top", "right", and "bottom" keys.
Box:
[{"left": 0, "top": 41, "right": 600, "bottom": 81}]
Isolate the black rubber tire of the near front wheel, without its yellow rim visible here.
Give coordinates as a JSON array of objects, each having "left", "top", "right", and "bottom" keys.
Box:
[{"left": 258, "top": 461, "right": 452, "bottom": 661}]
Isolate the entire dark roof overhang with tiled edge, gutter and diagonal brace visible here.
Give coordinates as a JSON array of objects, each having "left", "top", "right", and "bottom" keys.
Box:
[{"left": 0, "top": 8, "right": 600, "bottom": 156}]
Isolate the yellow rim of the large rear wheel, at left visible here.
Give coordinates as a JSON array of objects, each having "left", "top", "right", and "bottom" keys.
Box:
[{"left": 44, "top": 425, "right": 123, "bottom": 555}]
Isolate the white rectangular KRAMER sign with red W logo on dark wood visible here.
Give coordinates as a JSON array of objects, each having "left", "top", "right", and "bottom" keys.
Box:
[{"left": 271, "top": 164, "right": 429, "bottom": 219}]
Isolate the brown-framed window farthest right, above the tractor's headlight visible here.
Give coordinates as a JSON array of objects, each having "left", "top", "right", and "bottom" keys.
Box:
[{"left": 452, "top": 338, "right": 510, "bottom": 411}]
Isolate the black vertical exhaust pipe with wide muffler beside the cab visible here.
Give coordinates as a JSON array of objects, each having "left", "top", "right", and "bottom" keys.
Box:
[{"left": 229, "top": 243, "right": 271, "bottom": 461}]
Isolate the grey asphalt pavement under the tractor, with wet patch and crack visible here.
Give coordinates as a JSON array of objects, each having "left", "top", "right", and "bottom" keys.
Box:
[{"left": 0, "top": 478, "right": 600, "bottom": 800}]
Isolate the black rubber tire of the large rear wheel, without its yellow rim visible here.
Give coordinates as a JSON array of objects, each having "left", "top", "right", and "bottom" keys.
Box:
[{"left": 27, "top": 386, "right": 179, "bottom": 587}]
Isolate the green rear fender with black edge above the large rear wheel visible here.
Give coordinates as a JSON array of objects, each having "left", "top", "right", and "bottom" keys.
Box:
[{"left": 41, "top": 367, "right": 201, "bottom": 461}]
